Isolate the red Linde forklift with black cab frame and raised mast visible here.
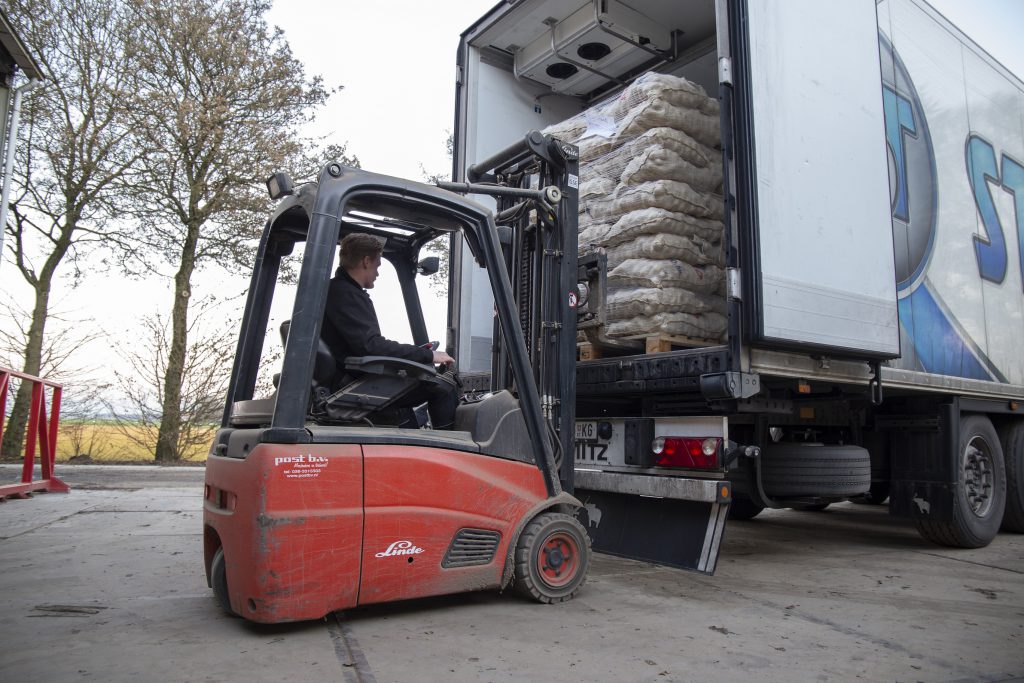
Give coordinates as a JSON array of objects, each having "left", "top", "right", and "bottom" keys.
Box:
[{"left": 203, "top": 131, "right": 591, "bottom": 624}]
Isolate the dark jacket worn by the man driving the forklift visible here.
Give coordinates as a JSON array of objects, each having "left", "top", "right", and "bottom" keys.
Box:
[{"left": 321, "top": 267, "right": 434, "bottom": 365}]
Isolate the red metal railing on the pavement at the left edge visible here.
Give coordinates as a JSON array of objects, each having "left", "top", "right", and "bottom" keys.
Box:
[{"left": 0, "top": 368, "right": 70, "bottom": 499}]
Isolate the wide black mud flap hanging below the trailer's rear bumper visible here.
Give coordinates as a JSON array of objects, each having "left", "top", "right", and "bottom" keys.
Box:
[{"left": 575, "top": 487, "right": 729, "bottom": 574}]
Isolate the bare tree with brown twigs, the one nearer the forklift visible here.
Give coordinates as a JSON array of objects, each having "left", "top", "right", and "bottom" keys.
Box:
[{"left": 119, "top": 0, "right": 329, "bottom": 461}]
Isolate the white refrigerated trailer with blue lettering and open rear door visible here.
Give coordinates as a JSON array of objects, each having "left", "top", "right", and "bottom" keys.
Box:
[{"left": 450, "top": 0, "right": 1024, "bottom": 552}]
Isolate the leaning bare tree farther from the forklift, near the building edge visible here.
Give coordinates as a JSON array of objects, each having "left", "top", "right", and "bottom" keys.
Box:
[{"left": 2, "top": 0, "right": 137, "bottom": 455}]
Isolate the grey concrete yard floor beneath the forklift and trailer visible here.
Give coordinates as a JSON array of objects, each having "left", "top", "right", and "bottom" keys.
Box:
[{"left": 0, "top": 466, "right": 1024, "bottom": 683}]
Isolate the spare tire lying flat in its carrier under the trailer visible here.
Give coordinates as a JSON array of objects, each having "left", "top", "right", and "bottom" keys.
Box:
[{"left": 761, "top": 443, "right": 871, "bottom": 498}]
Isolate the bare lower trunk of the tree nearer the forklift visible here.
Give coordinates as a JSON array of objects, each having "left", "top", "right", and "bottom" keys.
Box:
[{"left": 156, "top": 225, "right": 199, "bottom": 463}]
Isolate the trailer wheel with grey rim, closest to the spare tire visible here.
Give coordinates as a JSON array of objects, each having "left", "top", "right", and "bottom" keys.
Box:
[{"left": 914, "top": 415, "right": 1007, "bottom": 548}]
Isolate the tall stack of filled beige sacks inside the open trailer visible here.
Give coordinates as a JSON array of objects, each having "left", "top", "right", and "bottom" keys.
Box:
[{"left": 544, "top": 74, "right": 726, "bottom": 341}]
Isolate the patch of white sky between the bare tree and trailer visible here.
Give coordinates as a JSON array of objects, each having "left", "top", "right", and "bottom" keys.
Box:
[{"left": 267, "top": 0, "right": 497, "bottom": 179}]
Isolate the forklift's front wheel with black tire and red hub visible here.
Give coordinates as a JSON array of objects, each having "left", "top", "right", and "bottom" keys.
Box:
[{"left": 515, "top": 512, "right": 590, "bottom": 604}]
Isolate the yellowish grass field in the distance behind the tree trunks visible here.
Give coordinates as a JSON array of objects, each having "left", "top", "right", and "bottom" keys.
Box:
[{"left": 56, "top": 420, "right": 215, "bottom": 463}]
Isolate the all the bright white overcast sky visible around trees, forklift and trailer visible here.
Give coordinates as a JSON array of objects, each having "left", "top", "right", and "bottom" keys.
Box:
[{"left": 0, "top": 0, "right": 1024, "bottom": 395}]
